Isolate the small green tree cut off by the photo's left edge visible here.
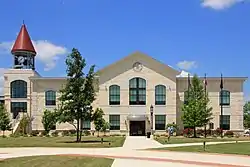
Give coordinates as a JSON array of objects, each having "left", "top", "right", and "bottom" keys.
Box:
[{"left": 0, "top": 104, "right": 11, "bottom": 137}]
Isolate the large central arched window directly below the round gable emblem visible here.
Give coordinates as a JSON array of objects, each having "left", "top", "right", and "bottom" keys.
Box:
[{"left": 129, "top": 77, "right": 146, "bottom": 105}]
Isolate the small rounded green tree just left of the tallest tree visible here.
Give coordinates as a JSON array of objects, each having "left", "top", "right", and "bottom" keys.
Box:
[{"left": 42, "top": 109, "right": 57, "bottom": 134}]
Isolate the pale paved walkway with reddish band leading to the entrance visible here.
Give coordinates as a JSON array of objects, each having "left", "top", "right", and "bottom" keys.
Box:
[{"left": 0, "top": 137, "right": 250, "bottom": 167}]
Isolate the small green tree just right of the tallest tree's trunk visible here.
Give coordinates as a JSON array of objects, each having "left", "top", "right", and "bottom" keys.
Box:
[{"left": 93, "top": 108, "right": 105, "bottom": 137}]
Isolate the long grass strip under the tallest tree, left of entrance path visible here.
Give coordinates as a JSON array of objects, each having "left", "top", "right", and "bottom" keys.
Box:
[{"left": 0, "top": 136, "right": 125, "bottom": 148}]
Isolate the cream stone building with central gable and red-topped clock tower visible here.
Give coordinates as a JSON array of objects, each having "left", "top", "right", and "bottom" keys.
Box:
[{"left": 4, "top": 25, "right": 247, "bottom": 135}]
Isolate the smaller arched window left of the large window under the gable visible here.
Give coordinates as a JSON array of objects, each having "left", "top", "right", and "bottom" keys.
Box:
[{"left": 109, "top": 85, "right": 120, "bottom": 105}]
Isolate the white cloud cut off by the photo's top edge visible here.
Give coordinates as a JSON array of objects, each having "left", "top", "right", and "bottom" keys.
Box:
[{"left": 202, "top": 0, "right": 245, "bottom": 10}]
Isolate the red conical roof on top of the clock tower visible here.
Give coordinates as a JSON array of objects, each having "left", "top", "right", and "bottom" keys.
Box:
[{"left": 11, "top": 24, "right": 36, "bottom": 54}]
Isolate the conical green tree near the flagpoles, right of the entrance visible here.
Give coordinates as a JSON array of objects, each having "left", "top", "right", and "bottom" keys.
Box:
[{"left": 182, "top": 75, "right": 212, "bottom": 137}]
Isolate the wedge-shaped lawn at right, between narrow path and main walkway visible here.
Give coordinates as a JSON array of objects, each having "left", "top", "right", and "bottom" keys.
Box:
[{"left": 157, "top": 143, "right": 250, "bottom": 155}]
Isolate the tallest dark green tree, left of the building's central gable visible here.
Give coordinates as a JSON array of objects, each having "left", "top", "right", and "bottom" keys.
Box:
[{"left": 57, "top": 48, "right": 95, "bottom": 142}]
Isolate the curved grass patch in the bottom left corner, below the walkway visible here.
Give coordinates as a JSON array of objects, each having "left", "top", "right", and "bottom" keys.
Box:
[{"left": 0, "top": 156, "right": 113, "bottom": 167}]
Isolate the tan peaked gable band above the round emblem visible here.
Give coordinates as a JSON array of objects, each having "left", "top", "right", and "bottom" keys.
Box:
[{"left": 97, "top": 51, "right": 180, "bottom": 83}]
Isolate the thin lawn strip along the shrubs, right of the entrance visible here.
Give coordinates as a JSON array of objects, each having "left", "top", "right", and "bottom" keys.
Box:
[{"left": 155, "top": 136, "right": 250, "bottom": 144}]
